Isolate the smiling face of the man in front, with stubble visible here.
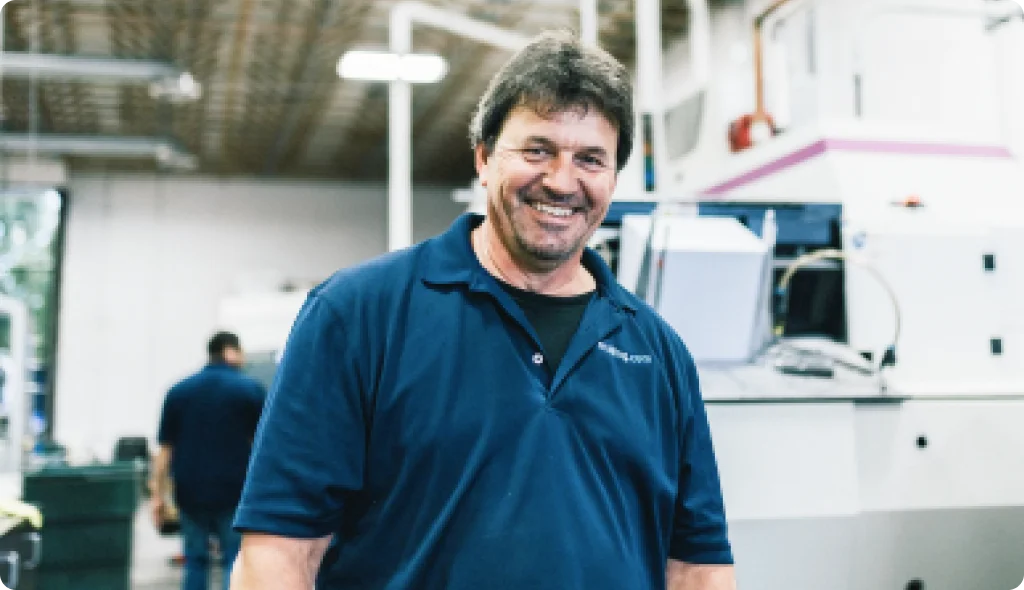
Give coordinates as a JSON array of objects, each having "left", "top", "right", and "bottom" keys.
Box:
[{"left": 476, "top": 107, "right": 618, "bottom": 270}]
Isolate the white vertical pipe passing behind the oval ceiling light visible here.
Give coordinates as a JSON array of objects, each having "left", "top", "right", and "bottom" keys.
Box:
[{"left": 387, "top": 9, "right": 413, "bottom": 251}]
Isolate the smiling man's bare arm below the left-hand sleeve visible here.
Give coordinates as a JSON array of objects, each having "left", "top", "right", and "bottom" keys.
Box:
[{"left": 231, "top": 533, "right": 331, "bottom": 590}]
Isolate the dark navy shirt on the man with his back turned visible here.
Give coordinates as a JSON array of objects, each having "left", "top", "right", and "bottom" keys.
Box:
[{"left": 157, "top": 364, "right": 266, "bottom": 513}]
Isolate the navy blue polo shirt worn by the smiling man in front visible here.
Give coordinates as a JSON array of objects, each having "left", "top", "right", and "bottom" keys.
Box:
[{"left": 236, "top": 214, "right": 732, "bottom": 590}]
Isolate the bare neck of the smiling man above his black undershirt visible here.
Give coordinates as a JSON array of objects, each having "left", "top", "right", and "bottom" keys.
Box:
[{"left": 470, "top": 220, "right": 597, "bottom": 297}]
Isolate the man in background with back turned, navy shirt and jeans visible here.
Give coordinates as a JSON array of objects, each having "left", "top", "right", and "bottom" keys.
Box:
[{"left": 150, "top": 332, "right": 265, "bottom": 590}]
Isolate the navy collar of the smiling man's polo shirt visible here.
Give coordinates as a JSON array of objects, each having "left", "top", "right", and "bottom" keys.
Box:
[{"left": 421, "top": 213, "right": 637, "bottom": 311}]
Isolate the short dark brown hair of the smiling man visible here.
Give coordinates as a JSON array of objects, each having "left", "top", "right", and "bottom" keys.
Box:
[{"left": 469, "top": 31, "right": 635, "bottom": 170}]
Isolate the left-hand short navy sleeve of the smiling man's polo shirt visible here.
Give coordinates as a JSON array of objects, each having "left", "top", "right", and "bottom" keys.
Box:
[{"left": 234, "top": 294, "right": 367, "bottom": 538}]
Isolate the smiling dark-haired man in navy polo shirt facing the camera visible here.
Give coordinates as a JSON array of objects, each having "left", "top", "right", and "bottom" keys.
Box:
[{"left": 232, "top": 34, "right": 734, "bottom": 590}]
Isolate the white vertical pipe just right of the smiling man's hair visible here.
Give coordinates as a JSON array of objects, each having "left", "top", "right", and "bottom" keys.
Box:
[{"left": 636, "top": 0, "right": 666, "bottom": 194}]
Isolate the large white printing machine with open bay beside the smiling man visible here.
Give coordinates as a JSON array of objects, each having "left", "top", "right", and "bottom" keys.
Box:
[{"left": 598, "top": 121, "right": 1024, "bottom": 590}]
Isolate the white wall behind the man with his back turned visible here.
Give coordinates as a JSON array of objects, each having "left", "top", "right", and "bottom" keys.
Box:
[{"left": 55, "top": 174, "right": 462, "bottom": 457}]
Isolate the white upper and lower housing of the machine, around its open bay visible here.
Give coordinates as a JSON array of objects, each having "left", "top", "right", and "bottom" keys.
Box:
[{"left": 618, "top": 121, "right": 1024, "bottom": 590}]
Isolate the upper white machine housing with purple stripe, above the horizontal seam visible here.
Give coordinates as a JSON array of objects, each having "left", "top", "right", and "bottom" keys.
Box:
[{"left": 699, "top": 120, "right": 1024, "bottom": 395}]
